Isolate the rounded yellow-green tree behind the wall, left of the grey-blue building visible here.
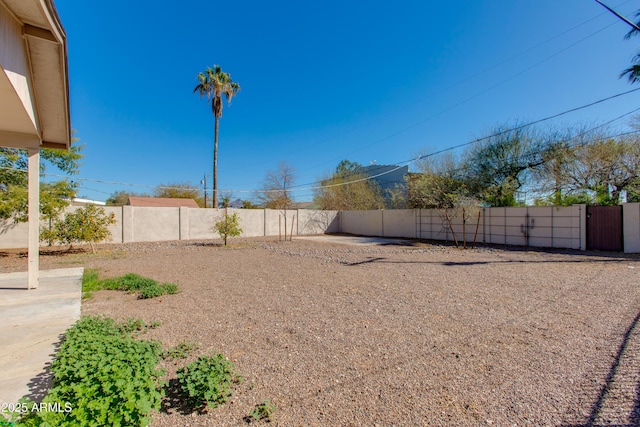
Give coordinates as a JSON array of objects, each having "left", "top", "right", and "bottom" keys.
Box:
[{"left": 314, "top": 160, "right": 384, "bottom": 210}]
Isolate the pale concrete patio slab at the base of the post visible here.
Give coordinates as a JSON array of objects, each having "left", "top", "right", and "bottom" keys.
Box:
[{"left": 0, "top": 267, "right": 84, "bottom": 410}]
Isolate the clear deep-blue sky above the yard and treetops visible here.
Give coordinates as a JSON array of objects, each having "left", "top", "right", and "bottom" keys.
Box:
[{"left": 55, "top": 0, "right": 640, "bottom": 201}]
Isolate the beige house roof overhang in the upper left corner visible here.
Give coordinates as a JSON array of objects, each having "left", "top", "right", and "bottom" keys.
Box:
[{"left": 0, "top": 0, "right": 71, "bottom": 149}]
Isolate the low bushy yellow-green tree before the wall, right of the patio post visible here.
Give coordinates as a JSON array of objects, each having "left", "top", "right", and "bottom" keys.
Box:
[{"left": 40, "top": 205, "right": 116, "bottom": 253}]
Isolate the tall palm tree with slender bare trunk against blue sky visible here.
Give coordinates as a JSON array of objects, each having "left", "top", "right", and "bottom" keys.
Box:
[{"left": 193, "top": 65, "right": 240, "bottom": 208}]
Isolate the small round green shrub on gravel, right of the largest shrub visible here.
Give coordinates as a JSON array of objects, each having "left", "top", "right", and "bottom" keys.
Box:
[{"left": 177, "top": 354, "right": 238, "bottom": 408}]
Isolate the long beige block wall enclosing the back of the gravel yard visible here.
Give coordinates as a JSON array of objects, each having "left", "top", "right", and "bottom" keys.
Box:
[{"left": 0, "top": 203, "right": 640, "bottom": 253}]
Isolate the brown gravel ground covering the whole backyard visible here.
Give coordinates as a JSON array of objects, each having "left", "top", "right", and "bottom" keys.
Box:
[{"left": 0, "top": 239, "right": 640, "bottom": 426}]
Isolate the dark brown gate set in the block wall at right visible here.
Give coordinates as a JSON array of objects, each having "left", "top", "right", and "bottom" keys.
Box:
[{"left": 587, "top": 206, "right": 623, "bottom": 252}]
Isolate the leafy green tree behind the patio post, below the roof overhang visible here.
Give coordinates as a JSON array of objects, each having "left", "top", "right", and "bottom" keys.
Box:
[{"left": 0, "top": 144, "right": 83, "bottom": 223}]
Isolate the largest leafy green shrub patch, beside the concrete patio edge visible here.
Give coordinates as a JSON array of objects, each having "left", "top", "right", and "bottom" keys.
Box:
[{"left": 18, "top": 317, "right": 162, "bottom": 427}]
